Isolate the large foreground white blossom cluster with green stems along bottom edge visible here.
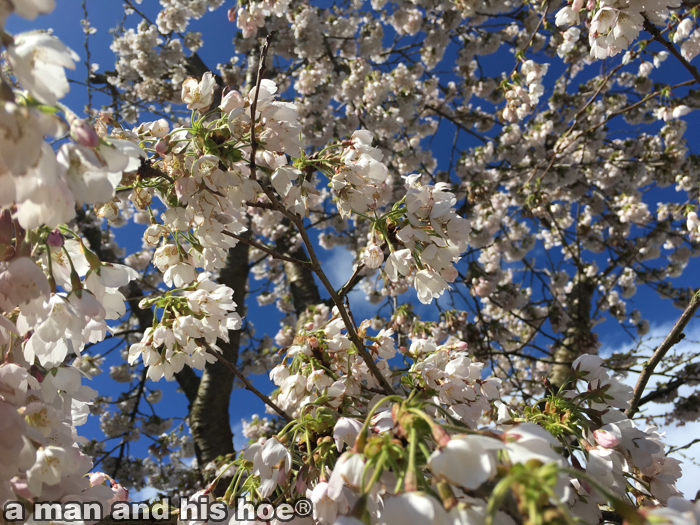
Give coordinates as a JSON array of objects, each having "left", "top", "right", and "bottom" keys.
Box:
[{"left": 223, "top": 332, "right": 685, "bottom": 525}]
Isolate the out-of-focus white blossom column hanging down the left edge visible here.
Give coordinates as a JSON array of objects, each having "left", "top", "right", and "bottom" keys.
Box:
[{"left": 0, "top": 1, "right": 145, "bottom": 504}]
